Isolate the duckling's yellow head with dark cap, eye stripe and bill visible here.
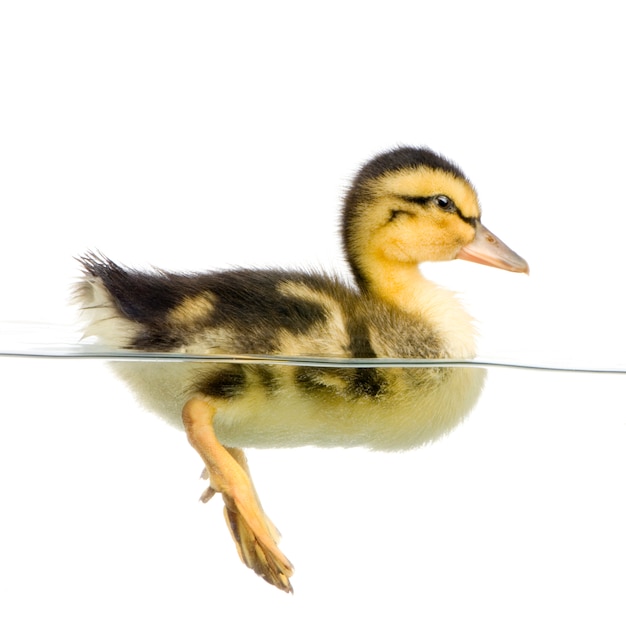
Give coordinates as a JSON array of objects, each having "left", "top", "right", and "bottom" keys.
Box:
[{"left": 342, "top": 147, "right": 528, "bottom": 291}]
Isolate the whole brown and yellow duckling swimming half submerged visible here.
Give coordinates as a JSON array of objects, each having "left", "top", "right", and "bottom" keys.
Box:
[{"left": 77, "top": 147, "right": 528, "bottom": 592}]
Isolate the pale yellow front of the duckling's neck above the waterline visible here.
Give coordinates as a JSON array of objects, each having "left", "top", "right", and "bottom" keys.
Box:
[{"left": 366, "top": 262, "right": 476, "bottom": 359}]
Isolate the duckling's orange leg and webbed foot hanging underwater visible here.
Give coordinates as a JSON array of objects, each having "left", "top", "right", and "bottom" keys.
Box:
[{"left": 183, "top": 397, "right": 293, "bottom": 592}]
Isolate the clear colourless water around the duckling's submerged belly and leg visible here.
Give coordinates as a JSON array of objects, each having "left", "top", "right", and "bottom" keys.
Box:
[{"left": 0, "top": 323, "right": 626, "bottom": 623}]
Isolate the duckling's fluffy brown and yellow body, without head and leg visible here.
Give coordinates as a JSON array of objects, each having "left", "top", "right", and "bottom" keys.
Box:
[{"left": 81, "top": 256, "right": 484, "bottom": 450}]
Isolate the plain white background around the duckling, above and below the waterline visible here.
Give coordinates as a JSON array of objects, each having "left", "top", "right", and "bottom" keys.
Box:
[{"left": 0, "top": 0, "right": 626, "bottom": 625}]
